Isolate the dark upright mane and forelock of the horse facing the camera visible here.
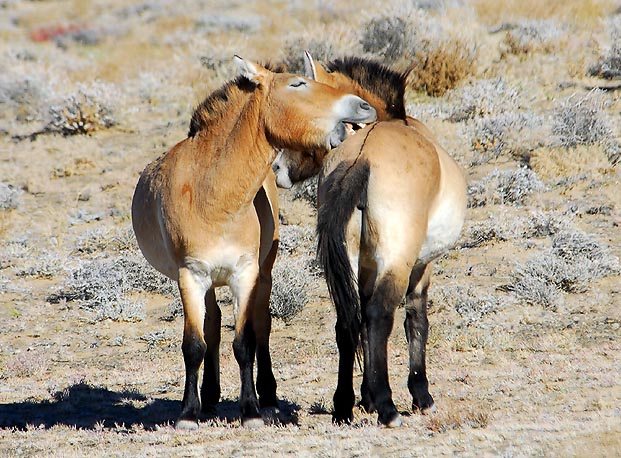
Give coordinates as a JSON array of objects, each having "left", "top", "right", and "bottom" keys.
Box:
[{"left": 188, "top": 62, "right": 286, "bottom": 137}]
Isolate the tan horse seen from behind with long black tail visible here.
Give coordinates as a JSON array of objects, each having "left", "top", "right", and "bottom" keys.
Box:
[{"left": 274, "top": 55, "right": 466, "bottom": 426}]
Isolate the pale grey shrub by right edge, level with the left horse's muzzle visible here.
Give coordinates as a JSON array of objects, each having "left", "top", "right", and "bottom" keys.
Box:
[{"left": 552, "top": 89, "right": 621, "bottom": 164}]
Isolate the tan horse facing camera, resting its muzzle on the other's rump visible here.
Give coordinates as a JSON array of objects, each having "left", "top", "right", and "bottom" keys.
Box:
[{"left": 132, "top": 57, "right": 375, "bottom": 428}]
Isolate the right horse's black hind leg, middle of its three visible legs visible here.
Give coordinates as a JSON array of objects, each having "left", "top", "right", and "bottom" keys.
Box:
[{"left": 365, "top": 273, "right": 407, "bottom": 427}]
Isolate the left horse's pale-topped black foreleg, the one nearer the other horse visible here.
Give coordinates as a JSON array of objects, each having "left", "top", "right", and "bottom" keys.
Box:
[{"left": 231, "top": 268, "right": 263, "bottom": 428}]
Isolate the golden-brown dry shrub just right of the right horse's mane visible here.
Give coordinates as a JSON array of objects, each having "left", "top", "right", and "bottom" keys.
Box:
[{"left": 408, "top": 39, "right": 476, "bottom": 97}]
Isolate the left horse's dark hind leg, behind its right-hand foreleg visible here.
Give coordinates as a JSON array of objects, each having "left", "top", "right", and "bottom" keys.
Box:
[{"left": 253, "top": 242, "right": 278, "bottom": 408}]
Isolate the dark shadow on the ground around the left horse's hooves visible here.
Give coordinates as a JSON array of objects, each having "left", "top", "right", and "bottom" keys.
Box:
[{"left": 0, "top": 382, "right": 300, "bottom": 431}]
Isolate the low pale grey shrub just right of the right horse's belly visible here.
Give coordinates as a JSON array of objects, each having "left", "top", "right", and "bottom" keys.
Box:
[{"left": 468, "top": 168, "right": 545, "bottom": 207}]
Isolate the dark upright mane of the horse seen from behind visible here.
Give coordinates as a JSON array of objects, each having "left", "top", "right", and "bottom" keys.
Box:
[{"left": 326, "top": 57, "right": 407, "bottom": 119}]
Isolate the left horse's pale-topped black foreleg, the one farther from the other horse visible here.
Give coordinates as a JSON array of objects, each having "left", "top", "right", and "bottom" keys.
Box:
[{"left": 175, "top": 268, "right": 207, "bottom": 429}]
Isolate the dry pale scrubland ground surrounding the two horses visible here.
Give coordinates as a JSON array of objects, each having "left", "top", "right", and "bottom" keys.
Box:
[{"left": 0, "top": 0, "right": 621, "bottom": 457}]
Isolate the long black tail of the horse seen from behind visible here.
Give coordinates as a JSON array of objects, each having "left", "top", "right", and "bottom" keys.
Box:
[{"left": 317, "top": 160, "right": 369, "bottom": 349}]
